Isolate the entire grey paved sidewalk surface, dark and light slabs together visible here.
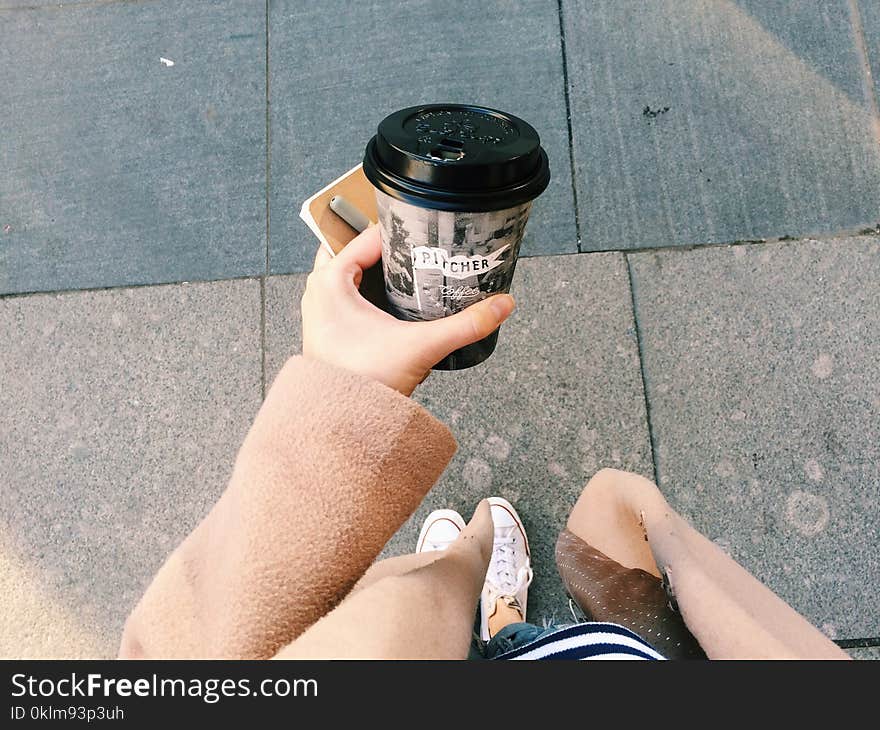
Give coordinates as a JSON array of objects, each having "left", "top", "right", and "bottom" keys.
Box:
[{"left": 0, "top": 0, "right": 880, "bottom": 659}]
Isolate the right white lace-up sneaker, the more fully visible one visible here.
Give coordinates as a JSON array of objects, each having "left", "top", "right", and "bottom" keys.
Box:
[{"left": 480, "top": 497, "right": 532, "bottom": 641}]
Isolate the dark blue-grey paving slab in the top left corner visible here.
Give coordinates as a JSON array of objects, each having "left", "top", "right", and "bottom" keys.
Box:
[{"left": 0, "top": 0, "right": 266, "bottom": 293}]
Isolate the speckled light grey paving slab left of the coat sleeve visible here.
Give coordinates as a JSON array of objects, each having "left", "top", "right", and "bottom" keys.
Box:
[{"left": 0, "top": 280, "right": 260, "bottom": 657}]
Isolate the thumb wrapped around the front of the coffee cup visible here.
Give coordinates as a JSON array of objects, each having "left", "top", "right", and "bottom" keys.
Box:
[{"left": 414, "top": 294, "right": 516, "bottom": 361}]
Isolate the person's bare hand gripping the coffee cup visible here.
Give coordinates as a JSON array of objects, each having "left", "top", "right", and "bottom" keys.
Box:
[{"left": 302, "top": 226, "right": 514, "bottom": 395}]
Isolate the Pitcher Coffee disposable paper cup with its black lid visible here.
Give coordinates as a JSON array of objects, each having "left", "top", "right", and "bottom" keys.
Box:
[{"left": 364, "top": 104, "right": 550, "bottom": 370}]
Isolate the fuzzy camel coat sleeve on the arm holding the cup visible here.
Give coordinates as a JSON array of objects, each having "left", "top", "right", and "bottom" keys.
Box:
[{"left": 119, "top": 357, "right": 456, "bottom": 658}]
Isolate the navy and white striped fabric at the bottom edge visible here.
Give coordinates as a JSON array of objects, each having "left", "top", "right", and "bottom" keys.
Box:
[{"left": 496, "top": 623, "right": 664, "bottom": 660}]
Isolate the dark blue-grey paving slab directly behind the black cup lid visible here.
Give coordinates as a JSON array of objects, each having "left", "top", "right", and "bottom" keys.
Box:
[{"left": 269, "top": 0, "right": 577, "bottom": 273}]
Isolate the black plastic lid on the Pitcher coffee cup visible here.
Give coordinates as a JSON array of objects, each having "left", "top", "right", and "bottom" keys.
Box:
[{"left": 364, "top": 104, "right": 550, "bottom": 212}]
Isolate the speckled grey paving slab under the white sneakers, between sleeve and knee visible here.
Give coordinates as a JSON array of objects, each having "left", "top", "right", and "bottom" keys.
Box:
[{"left": 266, "top": 254, "right": 652, "bottom": 623}]
